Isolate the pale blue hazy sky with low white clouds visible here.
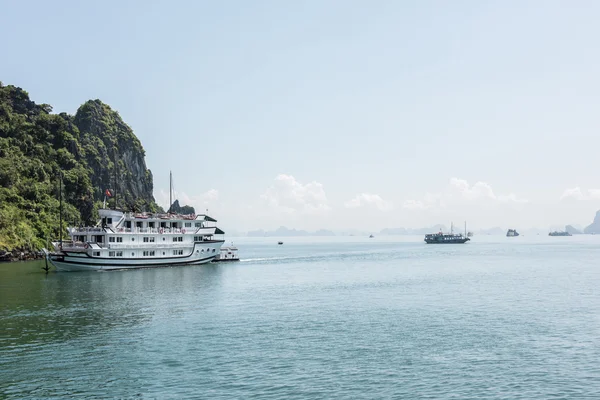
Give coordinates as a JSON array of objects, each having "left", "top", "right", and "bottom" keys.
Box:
[{"left": 0, "top": 0, "right": 600, "bottom": 231}]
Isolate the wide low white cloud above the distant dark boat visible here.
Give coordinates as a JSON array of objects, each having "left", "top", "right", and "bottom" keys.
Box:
[{"left": 402, "top": 178, "right": 528, "bottom": 210}]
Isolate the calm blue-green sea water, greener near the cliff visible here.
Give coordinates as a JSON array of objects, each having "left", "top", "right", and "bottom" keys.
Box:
[{"left": 0, "top": 236, "right": 600, "bottom": 399}]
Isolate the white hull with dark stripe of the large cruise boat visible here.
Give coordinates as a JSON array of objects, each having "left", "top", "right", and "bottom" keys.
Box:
[{"left": 46, "top": 242, "right": 222, "bottom": 272}]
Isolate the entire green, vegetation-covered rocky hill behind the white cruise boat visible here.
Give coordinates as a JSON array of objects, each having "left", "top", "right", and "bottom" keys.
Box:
[{"left": 0, "top": 82, "right": 158, "bottom": 250}]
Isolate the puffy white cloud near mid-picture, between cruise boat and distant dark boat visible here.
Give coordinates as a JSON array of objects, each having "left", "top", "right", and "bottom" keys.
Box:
[{"left": 260, "top": 174, "right": 330, "bottom": 214}]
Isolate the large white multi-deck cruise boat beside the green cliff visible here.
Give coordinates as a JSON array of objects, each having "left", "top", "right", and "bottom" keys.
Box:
[{"left": 46, "top": 209, "right": 225, "bottom": 271}]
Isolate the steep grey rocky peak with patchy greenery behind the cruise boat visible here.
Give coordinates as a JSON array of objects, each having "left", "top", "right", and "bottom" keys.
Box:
[{"left": 73, "top": 100, "right": 154, "bottom": 211}]
